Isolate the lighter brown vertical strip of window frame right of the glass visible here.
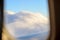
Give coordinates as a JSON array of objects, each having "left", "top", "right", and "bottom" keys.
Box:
[{"left": 48, "top": 0, "right": 56, "bottom": 40}]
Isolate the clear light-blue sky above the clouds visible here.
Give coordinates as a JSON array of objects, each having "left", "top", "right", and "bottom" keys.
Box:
[{"left": 5, "top": 0, "right": 49, "bottom": 15}]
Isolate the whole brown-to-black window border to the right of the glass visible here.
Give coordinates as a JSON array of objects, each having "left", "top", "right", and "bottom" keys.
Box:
[{"left": 48, "top": 0, "right": 60, "bottom": 40}]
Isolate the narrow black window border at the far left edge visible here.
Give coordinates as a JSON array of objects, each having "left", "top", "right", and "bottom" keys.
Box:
[{"left": 0, "top": 0, "right": 4, "bottom": 40}]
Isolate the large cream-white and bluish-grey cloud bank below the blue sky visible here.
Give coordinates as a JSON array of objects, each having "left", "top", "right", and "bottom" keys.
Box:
[{"left": 5, "top": 11, "right": 49, "bottom": 37}]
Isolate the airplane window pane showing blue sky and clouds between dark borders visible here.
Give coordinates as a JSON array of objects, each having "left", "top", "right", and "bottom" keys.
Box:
[{"left": 2, "top": 0, "right": 50, "bottom": 40}]
